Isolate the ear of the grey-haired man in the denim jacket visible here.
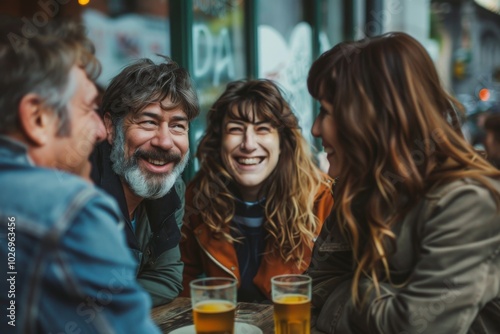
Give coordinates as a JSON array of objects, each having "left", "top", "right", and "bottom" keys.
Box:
[{"left": 19, "top": 93, "right": 58, "bottom": 146}]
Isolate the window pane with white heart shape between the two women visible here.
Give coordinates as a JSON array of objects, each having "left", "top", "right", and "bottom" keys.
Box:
[{"left": 258, "top": 0, "right": 314, "bottom": 142}]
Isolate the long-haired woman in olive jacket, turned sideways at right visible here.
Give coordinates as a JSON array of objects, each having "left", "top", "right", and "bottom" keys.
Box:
[{"left": 308, "top": 32, "right": 500, "bottom": 333}]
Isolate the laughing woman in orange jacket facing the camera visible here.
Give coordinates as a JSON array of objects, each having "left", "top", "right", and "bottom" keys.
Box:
[{"left": 181, "top": 80, "right": 333, "bottom": 302}]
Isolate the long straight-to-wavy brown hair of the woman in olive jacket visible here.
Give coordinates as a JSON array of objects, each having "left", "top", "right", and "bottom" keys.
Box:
[{"left": 307, "top": 33, "right": 500, "bottom": 305}]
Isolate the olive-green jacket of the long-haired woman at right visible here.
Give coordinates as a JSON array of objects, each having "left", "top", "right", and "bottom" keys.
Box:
[{"left": 317, "top": 184, "right": 500, "bottom": 334}]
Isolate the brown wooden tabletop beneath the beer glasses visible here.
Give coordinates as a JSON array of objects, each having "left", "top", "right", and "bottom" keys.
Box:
[{"left": 151, "top": 297, "right": 321, "bottom": 334}]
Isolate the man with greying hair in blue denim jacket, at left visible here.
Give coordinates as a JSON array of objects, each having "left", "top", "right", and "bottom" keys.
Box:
[{"left": 0, "top": 18, "right": 159, "bottom": 334}]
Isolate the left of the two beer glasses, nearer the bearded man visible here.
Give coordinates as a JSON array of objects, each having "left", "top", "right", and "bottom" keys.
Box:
[{"left": 189, "top": 277, "right": 237, "bottom": 334}]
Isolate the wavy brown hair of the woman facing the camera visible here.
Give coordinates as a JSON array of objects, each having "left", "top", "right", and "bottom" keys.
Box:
[{"left": 189, "top": 80, "right": 329, "bottom": 267}]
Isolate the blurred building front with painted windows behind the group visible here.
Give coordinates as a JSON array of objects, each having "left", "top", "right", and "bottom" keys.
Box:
[{"left": 0, "top": 0, "right": 460, "bottom": 179}]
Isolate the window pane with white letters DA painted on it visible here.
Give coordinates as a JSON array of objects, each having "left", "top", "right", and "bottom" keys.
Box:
[{"left": 190, "top": 0, "right": 247, "bottom": 170}]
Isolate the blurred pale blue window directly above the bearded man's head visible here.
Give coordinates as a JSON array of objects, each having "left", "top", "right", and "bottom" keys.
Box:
[{"left": 81, "top": 0, "right": 170, "bottom": 87}]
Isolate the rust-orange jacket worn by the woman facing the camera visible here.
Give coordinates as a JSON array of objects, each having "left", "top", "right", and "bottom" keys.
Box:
[{"left": 180, "top": 184, "right": 333, "bottom": 299}]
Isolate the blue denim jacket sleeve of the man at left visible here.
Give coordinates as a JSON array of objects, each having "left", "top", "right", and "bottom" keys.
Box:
[{"left": 39, "top": 194, "right": 160, "bottom": 334}]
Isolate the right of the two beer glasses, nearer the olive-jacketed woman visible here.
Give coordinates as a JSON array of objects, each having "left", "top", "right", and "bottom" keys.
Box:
[{"left": 271, "top": 275, "right": 311, "bottom": 334}]
